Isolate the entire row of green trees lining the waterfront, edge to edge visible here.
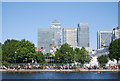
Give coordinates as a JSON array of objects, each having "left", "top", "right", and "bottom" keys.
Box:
[{"left": 0, "top": 39, "right": 120, "bottom": 66}]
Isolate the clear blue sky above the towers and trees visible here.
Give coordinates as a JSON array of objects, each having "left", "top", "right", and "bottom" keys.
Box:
[{"left": 2, "top": 2, "right": 118, "bottom": 49}]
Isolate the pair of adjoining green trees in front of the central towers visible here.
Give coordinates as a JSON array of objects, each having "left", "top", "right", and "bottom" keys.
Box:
[{"left": 55, "top": 43, "right": 91, "bottom": 64}]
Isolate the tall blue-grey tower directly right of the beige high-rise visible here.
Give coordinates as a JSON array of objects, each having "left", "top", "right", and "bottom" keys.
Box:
[{"left": 77, "top": 23, "right": 89, "bottom": 47}]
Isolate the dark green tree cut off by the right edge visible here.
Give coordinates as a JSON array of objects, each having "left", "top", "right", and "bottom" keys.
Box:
[{"left": 109, "top": 39, "right": 120, "bottom": 63}]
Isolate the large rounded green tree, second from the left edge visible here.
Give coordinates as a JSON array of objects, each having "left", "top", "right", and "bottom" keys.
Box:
[{"left": 15, "top": 39, "right": 35, "bottom": 63}]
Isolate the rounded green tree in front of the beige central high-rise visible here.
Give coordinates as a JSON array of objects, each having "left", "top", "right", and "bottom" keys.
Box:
[{"left": 54, "top": 43, "right": 74, "bottom": 63}]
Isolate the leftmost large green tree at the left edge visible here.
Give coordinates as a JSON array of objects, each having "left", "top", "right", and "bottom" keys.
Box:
[{"left": 2, "top": 39, "right": 19, "bottom": 63}]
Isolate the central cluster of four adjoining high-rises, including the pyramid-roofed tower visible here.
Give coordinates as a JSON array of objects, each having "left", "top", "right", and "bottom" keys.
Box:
[{"left": 37, "top": 20, "right": 89, "bottom": 53}]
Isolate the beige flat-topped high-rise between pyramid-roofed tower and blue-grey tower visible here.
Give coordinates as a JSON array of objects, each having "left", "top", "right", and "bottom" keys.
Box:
[{"left": 62, "top": 28, "right": 77, "bottom": 48}]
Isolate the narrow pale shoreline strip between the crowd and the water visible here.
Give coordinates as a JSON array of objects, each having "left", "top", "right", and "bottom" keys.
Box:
[{"left": 0, "top": 69, "right": 120, "bottom": 72}]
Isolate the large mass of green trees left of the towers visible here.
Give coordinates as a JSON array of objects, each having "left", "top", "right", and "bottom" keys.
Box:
[{"left": 0, "top": 39, "right": 45, "bottom": 65}]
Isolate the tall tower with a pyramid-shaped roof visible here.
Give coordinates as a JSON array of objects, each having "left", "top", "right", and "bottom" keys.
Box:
[{"left": 50, "top": 20, "right": 62, "bottom": 48}]
